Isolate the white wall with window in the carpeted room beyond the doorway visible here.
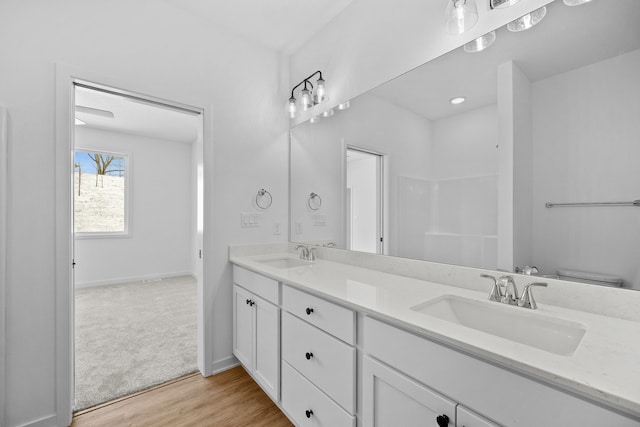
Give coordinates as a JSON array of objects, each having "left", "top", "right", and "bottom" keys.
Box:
[{"left": 74, "top": 126, "right": 195, "bottom": 286}]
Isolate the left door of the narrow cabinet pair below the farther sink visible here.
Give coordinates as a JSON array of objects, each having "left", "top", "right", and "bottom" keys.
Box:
[{"left": 233, "top": 285, "right": 255, "bottom": 372}]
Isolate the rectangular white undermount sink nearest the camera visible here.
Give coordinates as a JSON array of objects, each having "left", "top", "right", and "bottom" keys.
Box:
[{"left": 411, "top": 295, "right": 586, "bottom": 356}]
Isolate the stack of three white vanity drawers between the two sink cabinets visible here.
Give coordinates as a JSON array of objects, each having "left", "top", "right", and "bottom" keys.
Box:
[{"left": 282, "top": 286, "right": 356, "bottom": 427}]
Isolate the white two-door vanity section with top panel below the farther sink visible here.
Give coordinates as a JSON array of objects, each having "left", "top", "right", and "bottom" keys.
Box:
[{"left": 233, "top": 267, "right": 280, "bottom": 402}]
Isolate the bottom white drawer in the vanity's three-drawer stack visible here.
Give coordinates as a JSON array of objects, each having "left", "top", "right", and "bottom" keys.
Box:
[{"left": 282, "top": 362, "right": 356, "bottom": 427}]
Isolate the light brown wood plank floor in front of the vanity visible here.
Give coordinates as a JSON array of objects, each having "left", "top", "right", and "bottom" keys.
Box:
[{"left": 71, "top": 366, "right": 292, "bottom": 427}]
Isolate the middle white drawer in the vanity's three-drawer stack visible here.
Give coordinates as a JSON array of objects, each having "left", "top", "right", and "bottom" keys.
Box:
[{"left": 281, "top": 312, "right": 356, "bottom": 414}]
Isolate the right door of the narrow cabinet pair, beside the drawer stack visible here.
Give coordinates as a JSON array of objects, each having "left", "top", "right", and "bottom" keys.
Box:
[{"left": 253, "top": 296, "right": 280, "bottom": 401}]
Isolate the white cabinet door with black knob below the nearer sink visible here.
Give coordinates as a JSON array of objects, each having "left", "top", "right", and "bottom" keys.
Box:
[{"left": 362, "top": 356, "right": 456, "bottom": 427}]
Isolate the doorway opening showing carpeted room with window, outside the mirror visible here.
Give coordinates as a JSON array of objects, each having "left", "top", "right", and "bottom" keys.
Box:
[{"left": 71, "top": 82, "right": 203, "bottom": 411}]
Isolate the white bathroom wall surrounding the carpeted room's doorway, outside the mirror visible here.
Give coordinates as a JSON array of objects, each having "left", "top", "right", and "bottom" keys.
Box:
[{"left": 0, "top": 0, "right": 290, "bottom": 427}]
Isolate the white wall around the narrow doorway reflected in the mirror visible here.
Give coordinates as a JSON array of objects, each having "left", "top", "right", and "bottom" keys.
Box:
[{"left": 291, "top": 95, "right": 431, "bottom": 254}]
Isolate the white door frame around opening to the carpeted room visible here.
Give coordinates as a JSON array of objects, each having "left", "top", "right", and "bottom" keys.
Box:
[{"left": 55, "top": 63, "right": 213, "bottom": 425}]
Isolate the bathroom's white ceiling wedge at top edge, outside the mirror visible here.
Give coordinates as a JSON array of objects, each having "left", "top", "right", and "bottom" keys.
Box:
[{"left": 159, "top": 0, "right": 351, "bottom": 54}]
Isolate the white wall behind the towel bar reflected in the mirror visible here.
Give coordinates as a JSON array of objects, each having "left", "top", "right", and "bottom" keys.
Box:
[{"left": 532, "top": 51, "right": 640, "bottom": 289}]
